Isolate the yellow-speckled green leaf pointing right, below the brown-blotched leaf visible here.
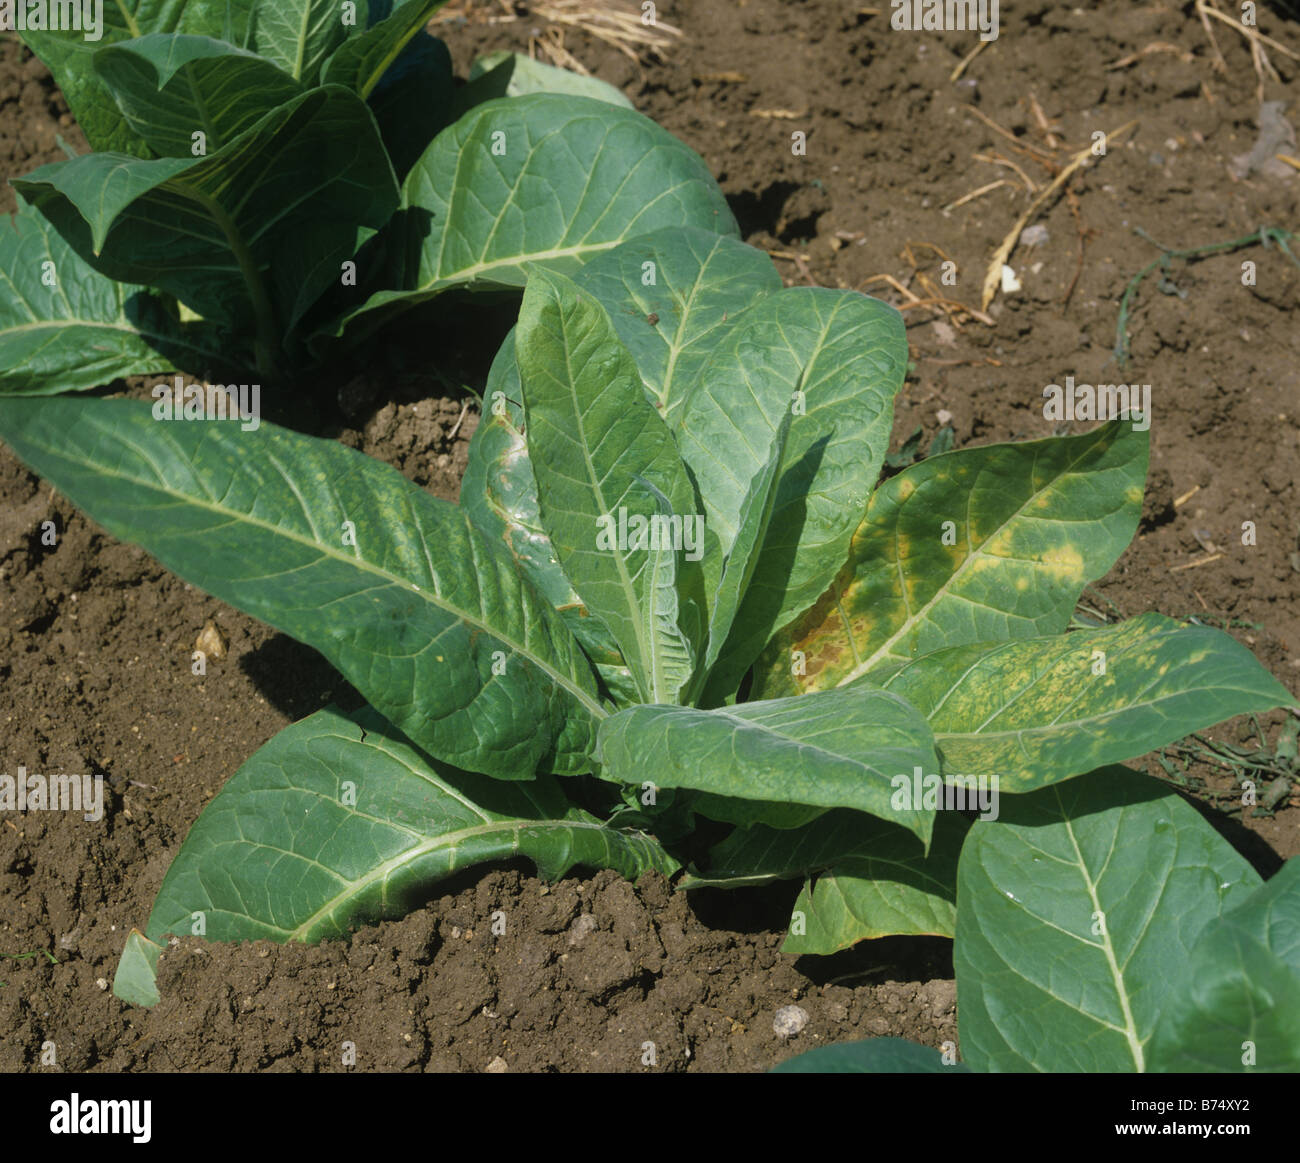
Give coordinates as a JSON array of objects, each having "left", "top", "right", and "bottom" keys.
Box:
[{"left": 853, "top": 613, "right": 1294, "bottom": 791}]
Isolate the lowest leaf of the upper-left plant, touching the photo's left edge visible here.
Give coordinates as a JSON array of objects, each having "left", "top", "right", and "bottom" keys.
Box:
[{"left": 0, "top": 200, "right": 220, "bottom": 395}]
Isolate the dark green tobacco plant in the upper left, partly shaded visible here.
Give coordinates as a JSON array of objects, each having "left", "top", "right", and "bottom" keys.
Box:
[{"left": 0, "top": 0, "right": 736, "bottom": 395}]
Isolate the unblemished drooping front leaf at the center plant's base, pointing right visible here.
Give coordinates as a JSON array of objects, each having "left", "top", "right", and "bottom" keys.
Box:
[{"left": 597, "top": 687, "right": 937, "bottom": 845}]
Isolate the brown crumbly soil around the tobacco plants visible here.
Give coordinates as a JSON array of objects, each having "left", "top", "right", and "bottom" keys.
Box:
[{"left": 0, "top": 0, "right": 1300, "bottom": 1072}]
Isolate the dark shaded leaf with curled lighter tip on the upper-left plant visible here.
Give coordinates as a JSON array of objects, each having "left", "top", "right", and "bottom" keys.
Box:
[{"left": 14, "top": 86, "right": 398, "bottom": 343}]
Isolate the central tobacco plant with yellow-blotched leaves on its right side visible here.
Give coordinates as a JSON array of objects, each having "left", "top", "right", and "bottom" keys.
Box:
[{"left": 0, "top": 229, "right": 1291, "bottom": 1018}]
